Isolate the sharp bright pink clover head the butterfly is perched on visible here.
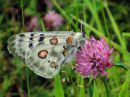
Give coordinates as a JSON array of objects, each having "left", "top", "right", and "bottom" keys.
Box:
[{"left": 75, "top": 37, "right": 113, "bottom": 78}]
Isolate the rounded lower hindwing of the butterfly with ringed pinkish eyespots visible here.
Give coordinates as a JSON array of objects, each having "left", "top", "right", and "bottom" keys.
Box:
[{"left": 25, "top": 45, "right": 64, "bottom": 78}]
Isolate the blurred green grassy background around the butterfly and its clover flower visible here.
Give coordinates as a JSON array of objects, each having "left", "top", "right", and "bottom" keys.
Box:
[{"left": 0, "top": 0, "right": 130, "bottom": 97}]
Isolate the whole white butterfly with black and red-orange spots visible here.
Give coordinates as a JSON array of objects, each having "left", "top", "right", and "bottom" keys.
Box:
[{"left": 7, "top": 31, "right": 85, "bottom": 78}]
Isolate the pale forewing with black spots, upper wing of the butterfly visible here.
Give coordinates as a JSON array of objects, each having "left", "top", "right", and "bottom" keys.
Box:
[{"left": 8, "top": 32, "right": 72, "bottom": 60}]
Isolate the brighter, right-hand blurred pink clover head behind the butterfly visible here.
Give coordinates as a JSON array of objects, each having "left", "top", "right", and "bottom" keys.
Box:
[{"left": 43, "top": 11, "right": 63, "bottom": 30}]
